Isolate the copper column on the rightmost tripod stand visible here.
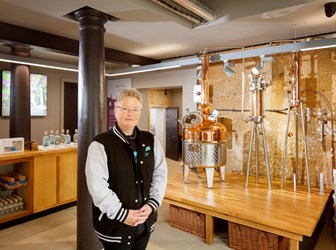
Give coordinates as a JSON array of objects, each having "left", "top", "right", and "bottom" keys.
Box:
[{"left": 291, "top": 52, "right": 300, "bottom": 107}]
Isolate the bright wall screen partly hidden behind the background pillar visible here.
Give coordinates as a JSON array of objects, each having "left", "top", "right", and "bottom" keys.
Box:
[{"left": 1, "top": 70, "right": 48, "bottom": 116}]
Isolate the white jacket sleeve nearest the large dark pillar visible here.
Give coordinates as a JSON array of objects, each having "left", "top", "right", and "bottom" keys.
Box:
[{"left": 85, "top": 141, "right": 128, "bottom": 222}]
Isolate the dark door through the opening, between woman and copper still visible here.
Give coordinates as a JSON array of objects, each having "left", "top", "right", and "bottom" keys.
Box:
[{"left": 166, "top": 107, "right": 179, "bottom": 161}]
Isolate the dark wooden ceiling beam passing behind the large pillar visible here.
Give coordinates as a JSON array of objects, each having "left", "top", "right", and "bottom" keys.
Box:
[{"left": 0, "top": 22, "right": 160, "bottom": 65}]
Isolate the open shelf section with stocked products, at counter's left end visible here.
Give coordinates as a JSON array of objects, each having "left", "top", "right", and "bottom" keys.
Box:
[{"left": 0, "top": 158, "right": 33, "bottom": 224}]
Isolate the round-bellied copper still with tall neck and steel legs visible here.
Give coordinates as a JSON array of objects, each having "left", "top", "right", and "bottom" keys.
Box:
[{"left": 179, "top": 54, "right": 227, "bottom": 188}]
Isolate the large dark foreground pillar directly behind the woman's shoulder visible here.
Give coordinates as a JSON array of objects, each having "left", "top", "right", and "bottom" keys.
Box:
[{"left": 75, "top": 8, "right": 108, "bottom": 250}]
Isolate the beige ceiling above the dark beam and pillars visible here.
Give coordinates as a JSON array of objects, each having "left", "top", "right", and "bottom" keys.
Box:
[{"left": 0, "top": 0, "right": 336, "bottom": 67}]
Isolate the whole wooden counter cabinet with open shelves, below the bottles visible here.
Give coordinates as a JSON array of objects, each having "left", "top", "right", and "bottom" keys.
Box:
[{"left": 0, "top": 147, "right": 77, "bottom": 225}]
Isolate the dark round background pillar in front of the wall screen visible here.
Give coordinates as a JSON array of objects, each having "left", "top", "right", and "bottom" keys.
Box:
[{"left": 9, "top": 45, "right": 31, "bottom": 142}]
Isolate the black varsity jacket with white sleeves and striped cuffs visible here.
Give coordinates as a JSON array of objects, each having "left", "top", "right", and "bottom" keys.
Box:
[{"left": 85, "top": 124, "right": 167, "bottom": 244}]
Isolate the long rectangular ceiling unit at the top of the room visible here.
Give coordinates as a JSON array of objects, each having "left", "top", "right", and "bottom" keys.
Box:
[{"left": 152, "top": 0, "right": 216, "bottom": 24}]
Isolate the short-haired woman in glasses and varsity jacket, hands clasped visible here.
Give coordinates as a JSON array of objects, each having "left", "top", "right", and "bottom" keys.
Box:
[{"left": 85, "top": 89, "right": 167, "bottom": 250}]
